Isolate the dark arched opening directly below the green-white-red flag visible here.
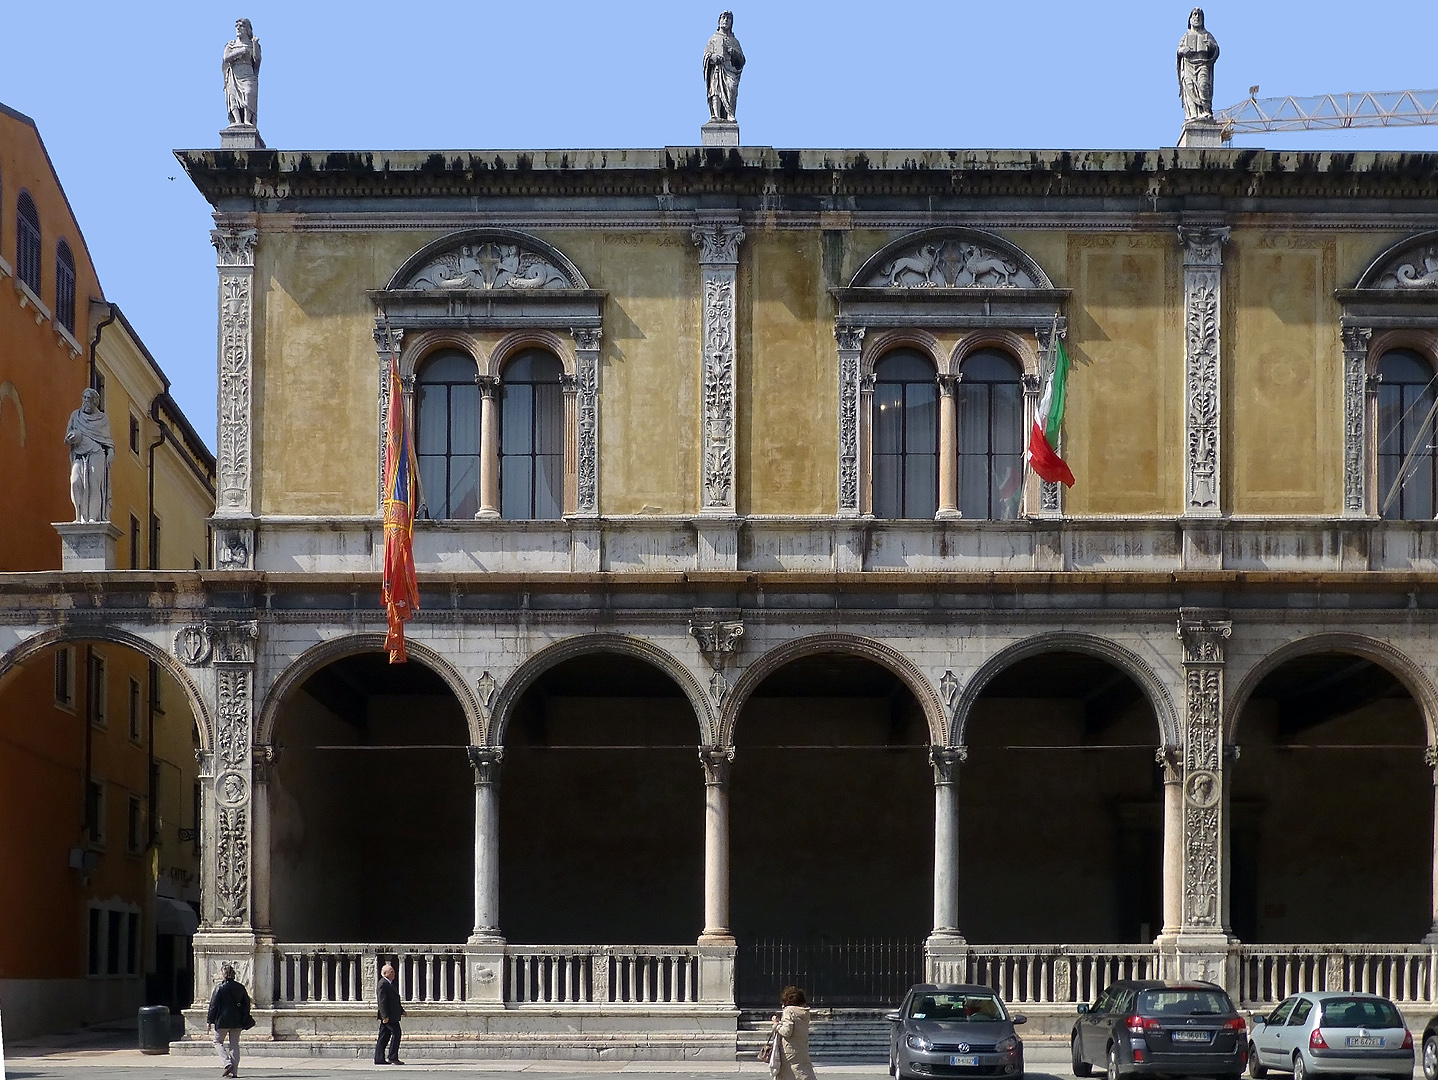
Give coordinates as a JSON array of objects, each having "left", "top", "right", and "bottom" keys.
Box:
[{"left": 959, "top": 650, "right": 1163, "bottom": 945}]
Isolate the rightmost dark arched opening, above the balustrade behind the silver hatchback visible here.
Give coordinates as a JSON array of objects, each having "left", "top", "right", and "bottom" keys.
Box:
[{"left": 1229, "top": 650, "right": 1434, "bottom": 943}]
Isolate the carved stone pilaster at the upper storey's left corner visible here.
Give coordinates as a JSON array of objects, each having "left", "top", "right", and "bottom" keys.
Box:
[{"left": 210, "top": 227, "right": 259, "bottom": 537}]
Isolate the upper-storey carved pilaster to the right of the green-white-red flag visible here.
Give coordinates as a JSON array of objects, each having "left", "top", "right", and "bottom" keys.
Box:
[{"left": 1178, "top": 224, "right": 1229, "bottom": 518}]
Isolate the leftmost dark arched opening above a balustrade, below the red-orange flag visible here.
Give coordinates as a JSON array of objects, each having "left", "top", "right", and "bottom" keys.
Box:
[{"left": 269, "top": 651, "right": 475, "bottom": 943}]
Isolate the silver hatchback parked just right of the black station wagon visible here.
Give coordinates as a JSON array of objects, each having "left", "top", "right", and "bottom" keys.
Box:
[{"left": 1248, "top": 992, "right": 1414, "bottom": 1080}]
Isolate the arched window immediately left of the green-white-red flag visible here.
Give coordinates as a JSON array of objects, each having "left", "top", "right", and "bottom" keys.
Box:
[{"left": 958, "top": 349, "right": 1024, "bottom": 521}]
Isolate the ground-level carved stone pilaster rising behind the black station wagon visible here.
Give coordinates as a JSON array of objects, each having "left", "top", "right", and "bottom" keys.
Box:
[{"left": 1178, "top": 613, "right": 1232, "bottom": 933}]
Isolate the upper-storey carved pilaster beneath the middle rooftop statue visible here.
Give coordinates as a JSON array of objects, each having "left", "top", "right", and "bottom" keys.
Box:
[{"left": 693, "top": 217, "right": 743, "bottom": 515}]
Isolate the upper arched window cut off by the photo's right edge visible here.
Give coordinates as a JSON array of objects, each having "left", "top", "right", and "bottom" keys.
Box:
[{"left": 1378, "top": 349, "right": 1438, "bottom": 521}]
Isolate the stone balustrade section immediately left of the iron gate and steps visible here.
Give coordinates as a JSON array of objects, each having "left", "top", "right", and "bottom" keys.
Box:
[{"left": 505, "top": 945, "right": 699, "bottom": 1005}]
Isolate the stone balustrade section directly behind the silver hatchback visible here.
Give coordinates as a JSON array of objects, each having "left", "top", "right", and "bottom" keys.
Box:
[{"left": 1240, "top": 945, "right": 1434, "bottom": 1005}]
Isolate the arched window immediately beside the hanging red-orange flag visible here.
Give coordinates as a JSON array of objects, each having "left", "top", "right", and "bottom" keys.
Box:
[{"left": 414, "top": 349, "right": 479, "bottom": 518}]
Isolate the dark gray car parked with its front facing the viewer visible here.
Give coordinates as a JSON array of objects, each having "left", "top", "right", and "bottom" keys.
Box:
[{"left": 886, "top": 984, "right": 1028, "bottom": 1080}]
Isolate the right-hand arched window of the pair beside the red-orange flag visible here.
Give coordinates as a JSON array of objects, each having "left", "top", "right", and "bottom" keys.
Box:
[{"left": 499, "top": 349, "right": 564, "bottom": 519}]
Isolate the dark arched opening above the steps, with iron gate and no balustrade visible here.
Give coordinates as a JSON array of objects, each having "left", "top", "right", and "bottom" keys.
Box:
[{"left": 731, "top": 653, "right": 933, "bottom": 1007}]
